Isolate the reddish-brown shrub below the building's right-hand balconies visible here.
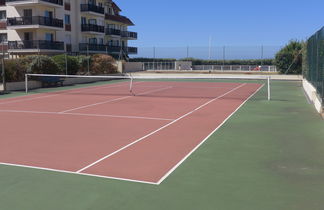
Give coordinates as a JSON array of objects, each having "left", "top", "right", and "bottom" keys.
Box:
[{"left": 91, "top": 54, "right": 117, "bottom": 74}]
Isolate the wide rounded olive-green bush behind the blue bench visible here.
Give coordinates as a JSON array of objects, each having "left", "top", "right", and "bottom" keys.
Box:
[{"left": 26, "top": 55, "right": 63, "bottom": 74}]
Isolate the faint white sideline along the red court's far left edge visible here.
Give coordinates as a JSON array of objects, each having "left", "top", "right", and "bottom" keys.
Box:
[{"left": 0, "top": 81, "right": 134, "bottom": 105}]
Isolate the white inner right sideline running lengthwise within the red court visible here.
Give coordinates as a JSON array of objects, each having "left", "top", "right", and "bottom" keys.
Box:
[{"left": 77, "top": 83, "right": 246, "bottom": 173}]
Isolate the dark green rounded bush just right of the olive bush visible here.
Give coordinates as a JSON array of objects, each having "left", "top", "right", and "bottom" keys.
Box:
[{"left": 52, "top": 54, "right": 80, "bottom": 75}]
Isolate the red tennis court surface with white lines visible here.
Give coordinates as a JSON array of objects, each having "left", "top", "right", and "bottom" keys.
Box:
[{"left": 0, "top": 82, "right": 262, "bottom": 184}]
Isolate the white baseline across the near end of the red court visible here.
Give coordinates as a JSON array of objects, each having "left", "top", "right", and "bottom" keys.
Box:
[{"left": 0, "top": 162, "right": 157, "bottom": 185}]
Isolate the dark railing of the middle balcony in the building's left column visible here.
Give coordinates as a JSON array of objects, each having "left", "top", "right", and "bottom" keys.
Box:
[{"left": 7, "top": 16, "right": 63, "bottom": 28}]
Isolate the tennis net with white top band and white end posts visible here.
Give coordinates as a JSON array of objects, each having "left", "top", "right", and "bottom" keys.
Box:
[{"left": 25, "top": 74, "right": 271, "bottom": 100}]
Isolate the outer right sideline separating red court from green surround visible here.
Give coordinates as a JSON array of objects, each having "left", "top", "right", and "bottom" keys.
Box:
[{"left": 157, "top": 85, "right": 264, "bottom": 185}]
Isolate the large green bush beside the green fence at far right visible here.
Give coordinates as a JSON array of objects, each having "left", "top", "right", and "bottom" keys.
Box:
[{"left": 275, "top": 41, "right": 304, "bottom": 74}]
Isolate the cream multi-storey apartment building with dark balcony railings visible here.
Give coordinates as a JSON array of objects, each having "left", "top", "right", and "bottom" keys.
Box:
[{"left": 0, "top": 0, "right": 137, "bottom": 57}]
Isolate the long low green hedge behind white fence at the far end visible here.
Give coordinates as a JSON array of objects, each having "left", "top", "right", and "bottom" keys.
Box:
[{"left": 129, "top": 58, "right": 275, "bottom": 66}]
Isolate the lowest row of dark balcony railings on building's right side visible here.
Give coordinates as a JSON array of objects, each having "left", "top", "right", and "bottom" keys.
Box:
[{"left": 79, "top": 43, "right": 137, "bottom": 54}]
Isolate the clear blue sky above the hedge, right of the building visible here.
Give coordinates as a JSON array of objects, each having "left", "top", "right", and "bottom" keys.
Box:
[{"left": 115, "top": 0, "right": 324, "bottom": 47}]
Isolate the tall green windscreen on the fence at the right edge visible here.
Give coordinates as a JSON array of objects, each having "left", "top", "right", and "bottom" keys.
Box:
[{"left": 304, "top": 28, "right": 324, "bottom": 100}]
